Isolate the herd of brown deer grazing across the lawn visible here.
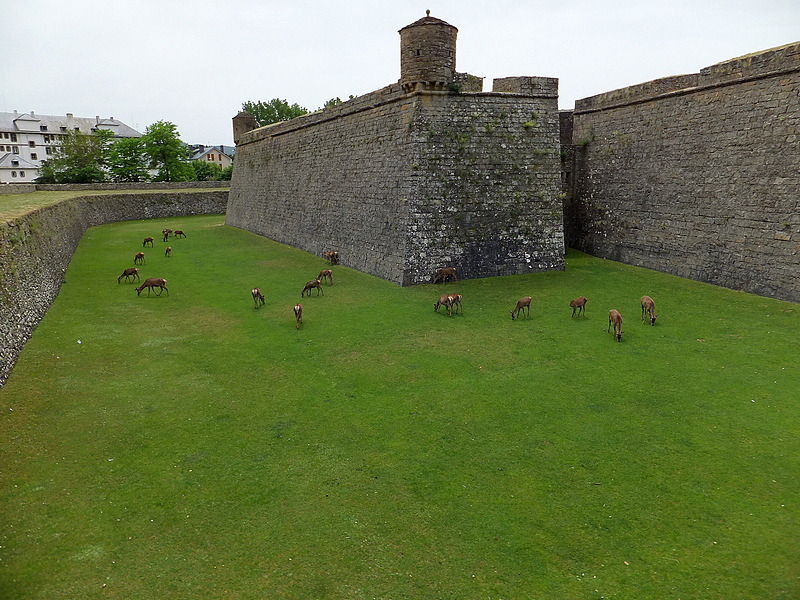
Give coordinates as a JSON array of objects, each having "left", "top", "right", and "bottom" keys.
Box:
[{"left": 117, "top": 229, "right": 656, "bottom": 342}]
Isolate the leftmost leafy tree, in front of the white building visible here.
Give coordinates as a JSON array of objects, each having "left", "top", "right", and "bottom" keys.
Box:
[{"left": 36, "top": 129, "right": 114, "bottom": 183}]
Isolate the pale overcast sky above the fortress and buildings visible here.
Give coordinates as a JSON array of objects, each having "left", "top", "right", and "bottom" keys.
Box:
[{"left": 0, "top": 0, "right": 800, "bottom": 145}]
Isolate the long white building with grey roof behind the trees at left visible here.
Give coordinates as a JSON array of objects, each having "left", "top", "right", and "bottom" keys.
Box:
[{"left": 0, "top": 111, "right": 142, "bottom": 183}]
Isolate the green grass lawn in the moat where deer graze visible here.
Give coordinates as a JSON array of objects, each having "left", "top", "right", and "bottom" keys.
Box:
[{"left": 0, "top": 216, "right": 800, "bottom": 600}]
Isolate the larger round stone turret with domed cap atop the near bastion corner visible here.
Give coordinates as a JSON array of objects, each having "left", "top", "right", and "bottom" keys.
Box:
[{"left": 399, "top": 11, "right": 458, "bottom": 93}]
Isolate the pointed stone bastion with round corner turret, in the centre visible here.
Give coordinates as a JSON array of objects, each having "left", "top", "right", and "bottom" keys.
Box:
[{"left": 226, "top": 17, "right": 564, "bottom": 285}]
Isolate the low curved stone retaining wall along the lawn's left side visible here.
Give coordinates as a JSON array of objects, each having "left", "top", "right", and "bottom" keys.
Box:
[{"left": 0, "top": 187, "right": 228, "bottom": 387}]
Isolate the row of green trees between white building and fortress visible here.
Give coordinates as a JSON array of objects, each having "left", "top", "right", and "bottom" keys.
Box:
[{"left": 36, "top": 121, "right": 233, "bottom": 183}]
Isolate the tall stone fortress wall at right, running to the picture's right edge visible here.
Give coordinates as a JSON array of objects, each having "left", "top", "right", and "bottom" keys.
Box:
[{"left": 563, "top": 43, "right": 800, "bottom": 302}]
